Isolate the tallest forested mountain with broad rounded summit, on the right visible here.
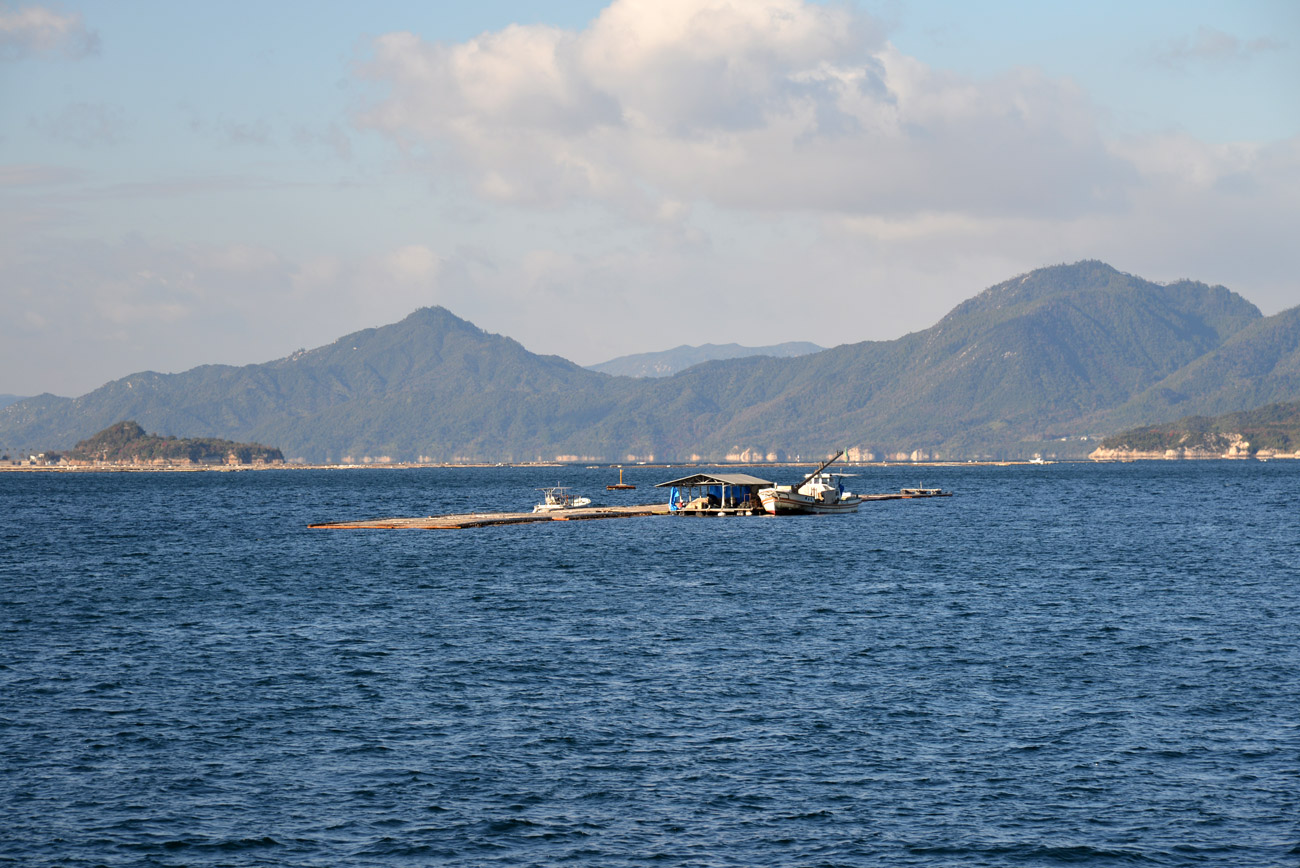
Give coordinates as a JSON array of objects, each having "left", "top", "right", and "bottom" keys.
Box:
[{"left": 618, "top": 262, "right": 1260, "bottom": 456}]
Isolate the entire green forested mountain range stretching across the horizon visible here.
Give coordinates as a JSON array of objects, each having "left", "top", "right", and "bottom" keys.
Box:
[{"left": 0, "top": 261, "right": 1300, "bottom": 461}]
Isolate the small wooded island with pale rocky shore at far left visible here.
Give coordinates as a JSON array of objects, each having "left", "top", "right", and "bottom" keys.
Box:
[{"left": 17, "top": 421, "right": 285, "bottom": 468}]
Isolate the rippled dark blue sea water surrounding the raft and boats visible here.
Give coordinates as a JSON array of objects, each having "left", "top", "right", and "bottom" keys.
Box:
[{"left": 0, "top": 461, "right": 1300, "bottom": 867}]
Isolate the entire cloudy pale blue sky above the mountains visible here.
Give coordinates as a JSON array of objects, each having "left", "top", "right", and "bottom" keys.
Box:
[{"left": 0, "top": 0, "right": 1300, "bottom": 396}]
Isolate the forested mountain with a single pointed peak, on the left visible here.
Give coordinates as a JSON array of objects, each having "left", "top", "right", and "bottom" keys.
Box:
[{"left": 0, "top": 308, "right": 627, "bottom": 461}]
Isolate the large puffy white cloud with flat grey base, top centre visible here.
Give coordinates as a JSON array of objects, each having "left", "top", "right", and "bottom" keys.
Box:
[{"left": 363, "top": 0, "right": 1132, "bottom": 216}]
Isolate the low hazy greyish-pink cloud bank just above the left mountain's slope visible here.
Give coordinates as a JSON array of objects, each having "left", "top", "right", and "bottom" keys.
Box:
[{"left": 0, "top": 235, "right": 449, "bottom": 394}]
